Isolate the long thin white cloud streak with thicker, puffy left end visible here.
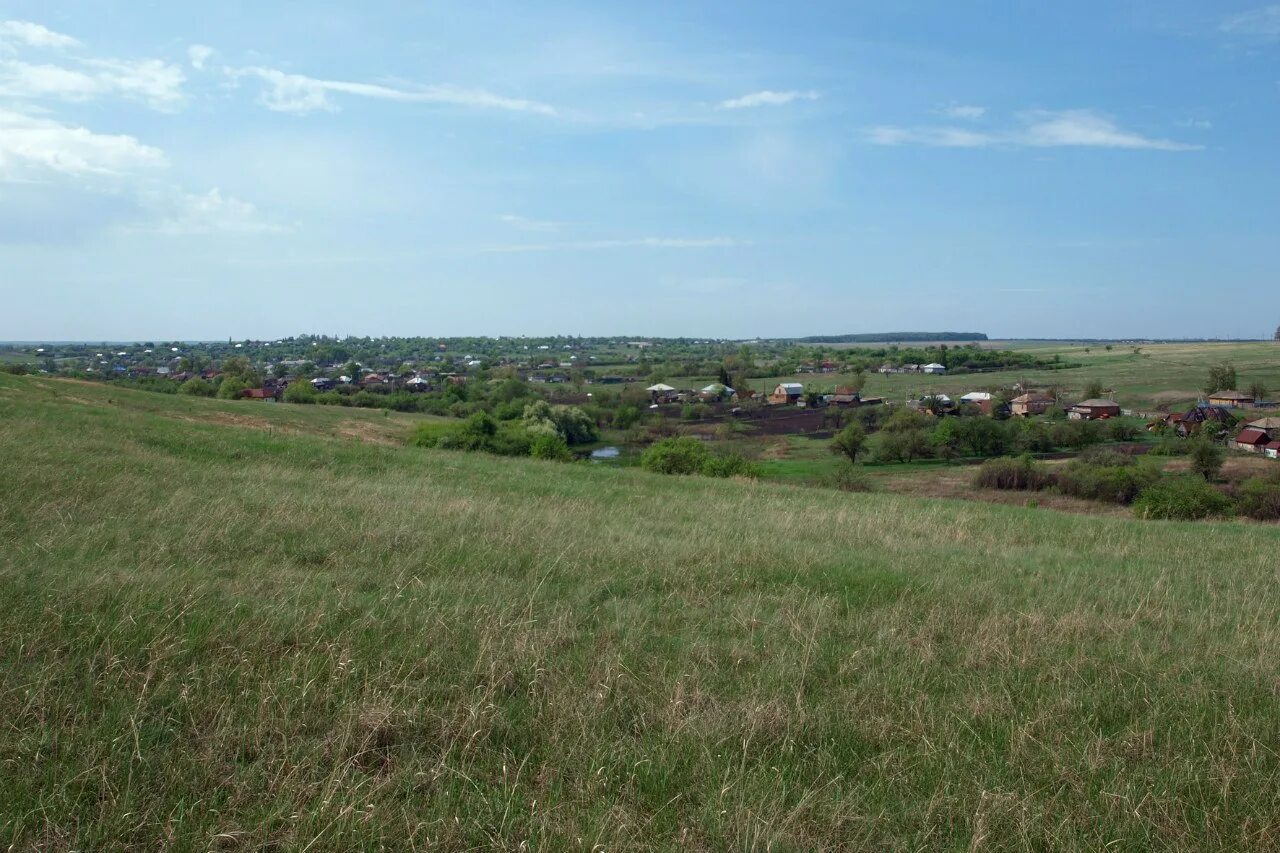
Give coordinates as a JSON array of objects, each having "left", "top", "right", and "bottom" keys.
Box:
[{"left": 228, "top": 67, "right": 556, "bottom": 115}]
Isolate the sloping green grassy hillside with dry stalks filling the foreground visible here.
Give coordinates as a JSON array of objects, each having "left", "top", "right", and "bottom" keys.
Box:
[{"left": 0, "top": 377, "right": 1280, "bottom": 850}]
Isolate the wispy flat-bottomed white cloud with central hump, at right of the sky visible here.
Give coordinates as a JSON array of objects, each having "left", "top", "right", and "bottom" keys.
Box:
[{"left": 867, "top": 110, "right": 1203, "bottom": 151}]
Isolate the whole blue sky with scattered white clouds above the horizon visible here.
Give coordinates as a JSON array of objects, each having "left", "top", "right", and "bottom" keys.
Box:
[{"left": 0, "top": 0, "right": 1280, "bottom": 339}]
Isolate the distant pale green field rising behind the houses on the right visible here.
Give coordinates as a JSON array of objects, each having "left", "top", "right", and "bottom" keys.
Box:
[{"left": 749, "top": 342, "right": 1280, "bottom": 410}]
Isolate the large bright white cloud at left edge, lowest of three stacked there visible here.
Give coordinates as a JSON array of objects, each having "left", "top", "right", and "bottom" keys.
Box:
[{"left": 0, "top": 109, "right": 166, "bottom": 181}]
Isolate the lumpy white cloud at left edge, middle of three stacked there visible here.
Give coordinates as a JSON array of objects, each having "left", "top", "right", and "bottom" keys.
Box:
[{"left": 0, "top": 59, "right": 186, "bottom": 110}]
